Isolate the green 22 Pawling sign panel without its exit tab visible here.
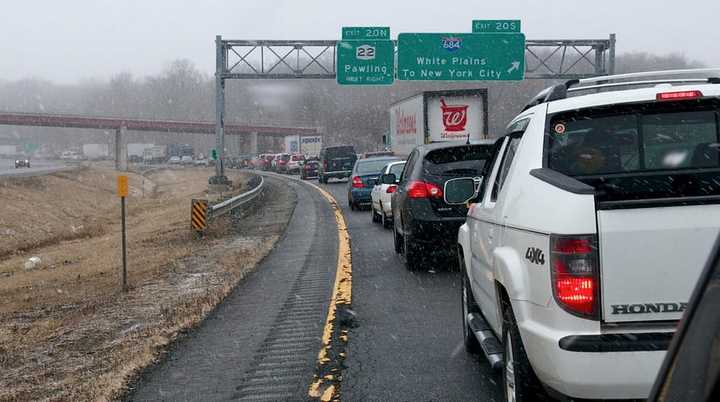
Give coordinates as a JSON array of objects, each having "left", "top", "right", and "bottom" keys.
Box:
[{"left": 336, "top": 40, "right": 395, "bottom": 85}]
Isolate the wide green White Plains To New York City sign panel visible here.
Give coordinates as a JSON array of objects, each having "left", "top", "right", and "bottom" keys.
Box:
[{"left": 397, "top": 33, "right": 525, "bottom": 81}]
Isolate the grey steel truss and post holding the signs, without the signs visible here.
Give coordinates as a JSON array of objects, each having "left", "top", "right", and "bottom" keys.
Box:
[{"left": 211, "top": 34, "right": 615, "bottom": 183}]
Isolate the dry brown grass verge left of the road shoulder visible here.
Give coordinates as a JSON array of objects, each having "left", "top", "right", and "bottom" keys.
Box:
[{"left": 0, "top": 168, "right": 286, "bottom": 400}]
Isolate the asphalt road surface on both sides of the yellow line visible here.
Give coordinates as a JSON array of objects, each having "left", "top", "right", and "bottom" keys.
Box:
[{"left": 127, "top": 174, "right": 503, "bottom": 401}]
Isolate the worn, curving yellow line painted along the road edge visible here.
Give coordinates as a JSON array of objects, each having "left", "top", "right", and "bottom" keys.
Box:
[{"left": 305, "top": 182, "right": 352, "bottom": 401}]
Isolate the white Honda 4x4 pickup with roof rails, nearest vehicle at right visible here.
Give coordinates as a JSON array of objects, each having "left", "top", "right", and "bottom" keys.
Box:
[{"left": 452, "top": 70, "right": 720, "bottom": 401}]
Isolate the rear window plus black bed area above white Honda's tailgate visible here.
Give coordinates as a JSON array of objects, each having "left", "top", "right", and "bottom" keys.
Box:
[{"left": 545, "top": 99, "right": 720, "bottom": 206}]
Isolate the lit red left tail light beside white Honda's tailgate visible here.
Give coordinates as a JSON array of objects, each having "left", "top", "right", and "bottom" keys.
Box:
[{"left": 550, "top": 235, "right": 600, "bottom": 320}]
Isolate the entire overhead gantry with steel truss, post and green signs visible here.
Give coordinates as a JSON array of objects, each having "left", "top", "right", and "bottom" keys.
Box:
[{"left": 210, "top": 20, "right": 615, "bottom": 184}]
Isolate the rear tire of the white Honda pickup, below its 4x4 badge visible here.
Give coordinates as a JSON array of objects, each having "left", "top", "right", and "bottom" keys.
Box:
[{"left": 502, "top": 303, "right": 546, "bottom": 402}]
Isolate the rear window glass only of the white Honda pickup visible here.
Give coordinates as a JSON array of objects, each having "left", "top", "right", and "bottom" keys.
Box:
[{"left": 547, "top": 102, "right": 720, "bottom": 177}]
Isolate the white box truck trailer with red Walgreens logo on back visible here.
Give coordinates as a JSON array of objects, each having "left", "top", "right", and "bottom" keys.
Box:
[{"left": 385, "top": 89, "right": 488, "bottom": 155}]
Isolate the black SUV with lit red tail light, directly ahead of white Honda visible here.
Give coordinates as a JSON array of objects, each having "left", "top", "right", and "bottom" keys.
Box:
[{"left": 388, "top": 141, "right": 493, "bottom": 270}]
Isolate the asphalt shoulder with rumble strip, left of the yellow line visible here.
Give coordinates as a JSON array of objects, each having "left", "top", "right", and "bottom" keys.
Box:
[{"left": 127, "top": 177, "right": 338, "bottom": 401}]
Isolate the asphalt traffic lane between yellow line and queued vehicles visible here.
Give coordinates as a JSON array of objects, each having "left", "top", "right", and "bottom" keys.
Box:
[{"left": 323, "top": 182, "right": 503, "bottom": 401}]
